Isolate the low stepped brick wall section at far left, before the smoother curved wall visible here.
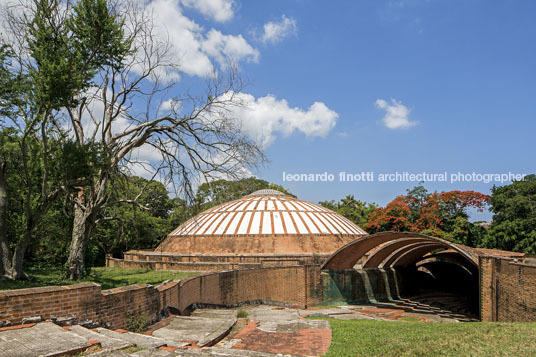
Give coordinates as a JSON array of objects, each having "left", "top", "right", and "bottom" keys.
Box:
[{"left": 0, "top": 282, "right": 178, "bottom": 328}]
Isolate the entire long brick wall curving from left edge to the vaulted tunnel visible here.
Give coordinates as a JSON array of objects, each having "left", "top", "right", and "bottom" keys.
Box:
[{"left": 0, "top": 266, "right": 319, "bottom": 328}]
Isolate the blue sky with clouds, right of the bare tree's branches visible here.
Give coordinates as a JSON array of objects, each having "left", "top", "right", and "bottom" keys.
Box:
[{"left": 101, "top": 0, "right": 536, "bottom": 219}]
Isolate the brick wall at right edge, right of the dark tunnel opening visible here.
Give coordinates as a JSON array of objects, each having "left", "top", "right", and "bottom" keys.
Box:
[{"left": 480, "top": 256, "right": 536, "bottom": 321}]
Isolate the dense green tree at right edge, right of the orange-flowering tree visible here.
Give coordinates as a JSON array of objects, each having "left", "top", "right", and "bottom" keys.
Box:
[{"left": 483, "top": 175, "right": 536, "bottom": 254}]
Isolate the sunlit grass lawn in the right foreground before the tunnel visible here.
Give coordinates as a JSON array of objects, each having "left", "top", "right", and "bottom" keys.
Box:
[{"left": 315, "top": 318, "right": 536, "bottom": 357}]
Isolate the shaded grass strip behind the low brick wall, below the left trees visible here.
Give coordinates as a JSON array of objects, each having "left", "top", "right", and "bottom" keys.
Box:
[{"left": 0, "top": 267, "right": 198, "bottom": 290}]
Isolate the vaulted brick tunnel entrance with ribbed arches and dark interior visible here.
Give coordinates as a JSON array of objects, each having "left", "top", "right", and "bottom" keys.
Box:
[{"left": 322, "top": 232, "right": 479, "bottom": 318}]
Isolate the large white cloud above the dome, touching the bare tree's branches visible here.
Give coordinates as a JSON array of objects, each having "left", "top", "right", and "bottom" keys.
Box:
[{"left": 222, "top": 93, "right": 339, "bottom": 149}]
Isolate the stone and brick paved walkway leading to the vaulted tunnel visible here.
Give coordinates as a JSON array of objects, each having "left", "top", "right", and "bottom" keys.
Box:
[{"left": 0, "top": 301, "right": 478, "bottom": 357}]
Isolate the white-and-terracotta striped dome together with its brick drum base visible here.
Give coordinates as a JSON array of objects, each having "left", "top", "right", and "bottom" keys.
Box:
[{"left": 155, "top": 189, "right": 367, "bottom": 254}]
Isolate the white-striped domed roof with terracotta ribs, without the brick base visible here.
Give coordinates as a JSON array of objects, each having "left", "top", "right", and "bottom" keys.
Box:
[{"left": 168, "top": 189, "right": 367, "bottom": 238}]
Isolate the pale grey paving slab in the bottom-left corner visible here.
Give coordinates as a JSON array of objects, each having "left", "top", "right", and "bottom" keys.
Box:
[{"left": 0, "top": 322, "right": 91, "bottom": 357}]
